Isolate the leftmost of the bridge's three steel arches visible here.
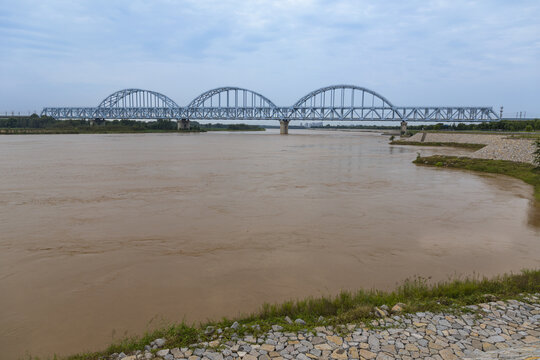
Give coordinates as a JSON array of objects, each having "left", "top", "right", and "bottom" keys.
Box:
[{"left": 98, "top": 89, "right": 179, "bottom": 109}]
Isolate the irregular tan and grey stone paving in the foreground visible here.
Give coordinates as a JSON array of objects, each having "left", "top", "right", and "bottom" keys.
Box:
[{"left": 109, "top": 294, "right": 540, "bottom": 360}]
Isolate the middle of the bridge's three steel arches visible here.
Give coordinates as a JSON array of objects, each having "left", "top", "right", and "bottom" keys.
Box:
[{"left": 187, "top": 86, "right": 277, "bottom": 109}]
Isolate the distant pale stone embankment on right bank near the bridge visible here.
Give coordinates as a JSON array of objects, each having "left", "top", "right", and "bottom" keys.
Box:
[{"left": 401, "top": 132, "right": 535, "bottom": 164}]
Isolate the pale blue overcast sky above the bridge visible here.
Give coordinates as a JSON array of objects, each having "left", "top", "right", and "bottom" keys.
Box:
[{"left": 0, "top": 0, "right": 540, "bottom": 117}]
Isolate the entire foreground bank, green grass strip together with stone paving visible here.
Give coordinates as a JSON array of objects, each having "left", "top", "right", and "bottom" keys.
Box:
[{"left": 60, "top": 270, "right": 540, "bottom": 360}]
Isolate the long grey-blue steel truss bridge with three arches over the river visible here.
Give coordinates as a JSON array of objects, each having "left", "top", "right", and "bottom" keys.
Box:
[{"left": 41, "top": 85, "right": 499, "bottom": 122}]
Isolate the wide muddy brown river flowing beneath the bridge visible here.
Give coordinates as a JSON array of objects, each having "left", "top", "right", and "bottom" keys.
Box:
[{"left": 0, "top": 129, "right": 540, "bottom": 359}]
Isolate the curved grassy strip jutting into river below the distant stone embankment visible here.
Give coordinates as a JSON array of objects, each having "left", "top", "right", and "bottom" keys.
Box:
[{"left": 413, "top": 155, "right": 540, "bottom": 201}]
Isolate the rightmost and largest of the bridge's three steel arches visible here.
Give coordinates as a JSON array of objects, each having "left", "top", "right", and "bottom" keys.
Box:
[{"left": 292, "top": 85, "right": 394, "bottom": 109}]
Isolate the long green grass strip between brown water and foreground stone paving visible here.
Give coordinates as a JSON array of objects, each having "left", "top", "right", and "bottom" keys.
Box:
[{"left": 37, "top": 270, "right": 540, "bottom": 360}]
